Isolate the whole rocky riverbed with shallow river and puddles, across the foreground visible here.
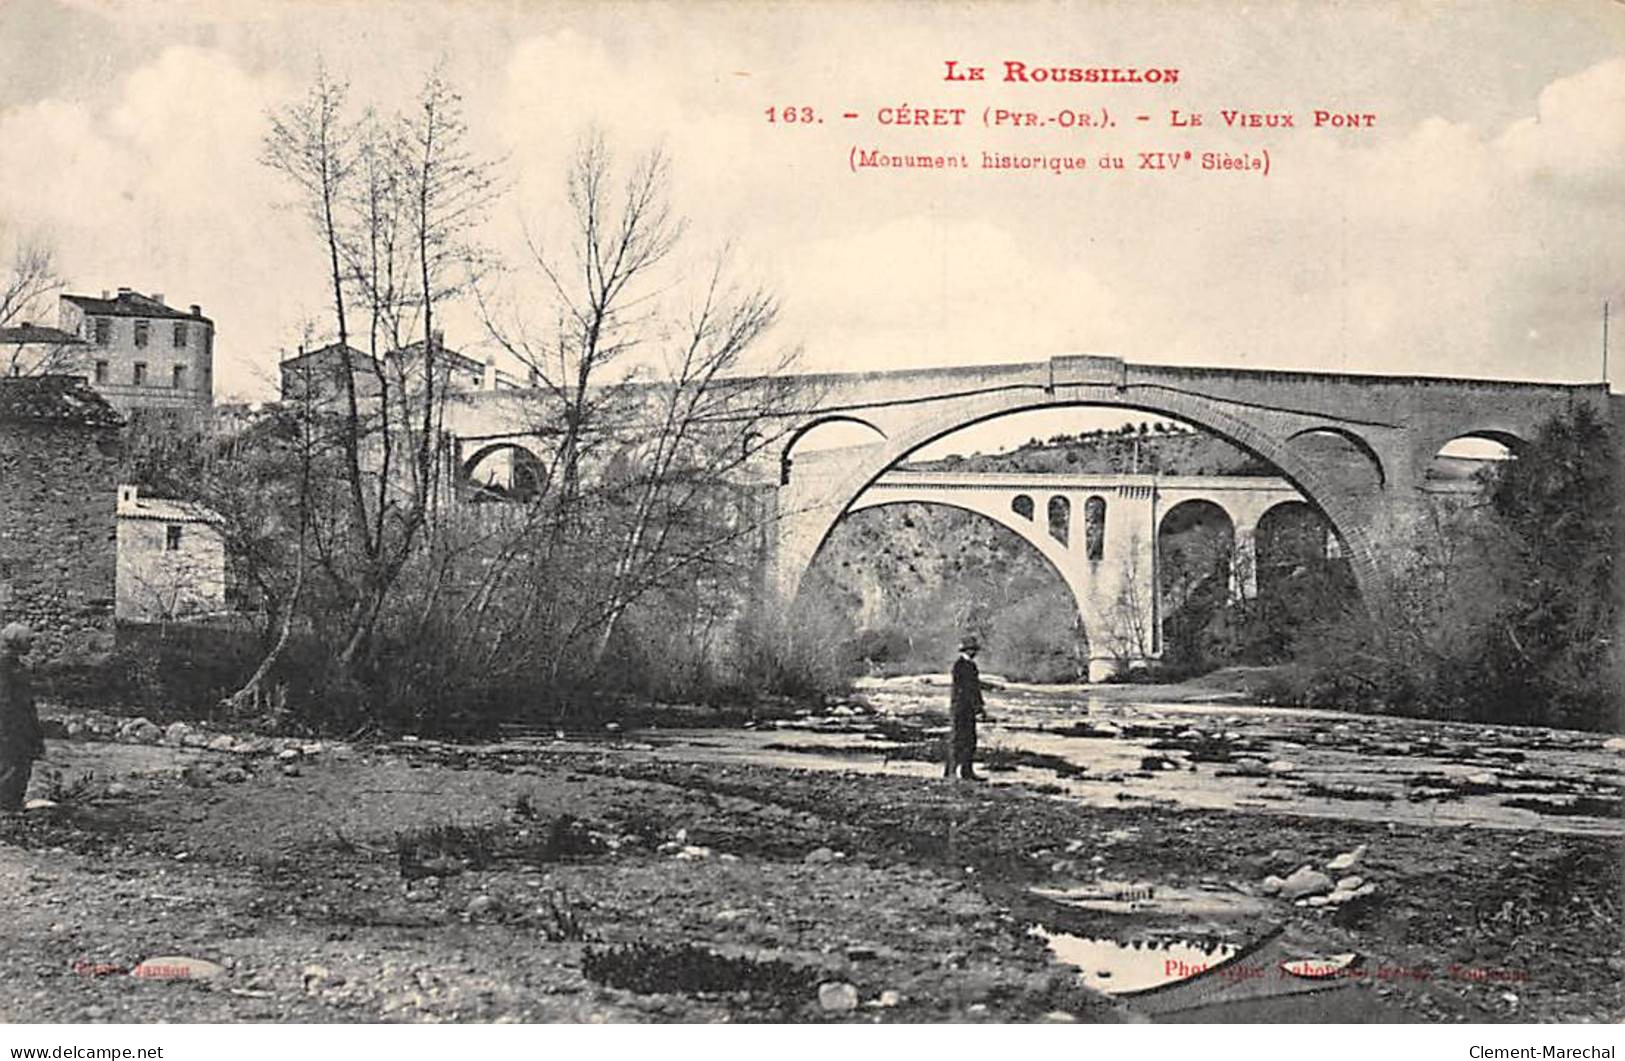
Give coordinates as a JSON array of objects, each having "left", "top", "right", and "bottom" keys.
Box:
[{"left": 0, "top": 682, "right": 1625, "bottom": 1022}]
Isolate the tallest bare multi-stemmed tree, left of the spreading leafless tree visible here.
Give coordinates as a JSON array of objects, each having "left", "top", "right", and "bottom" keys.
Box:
[{"left": 263, "top": 70, "right": 501, "bottom": 671}]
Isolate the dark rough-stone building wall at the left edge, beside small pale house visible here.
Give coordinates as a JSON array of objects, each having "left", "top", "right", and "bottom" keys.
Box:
[{"left": 0, "top": 375, "right": 122, "bottom": 661}]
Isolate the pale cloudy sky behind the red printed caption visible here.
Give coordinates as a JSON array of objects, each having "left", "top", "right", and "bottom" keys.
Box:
[{"left": 0, "top": 0, "right": 1625, "bottom": 396}]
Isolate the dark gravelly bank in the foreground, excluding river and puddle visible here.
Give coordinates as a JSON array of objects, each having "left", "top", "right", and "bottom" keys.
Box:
[{"left": 0, "top": 724, "right": 1622, "bottom": 1020}]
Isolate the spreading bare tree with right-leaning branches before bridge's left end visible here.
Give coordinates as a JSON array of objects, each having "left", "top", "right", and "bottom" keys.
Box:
[{"left": 486, "top": 133, "right": 798, "bottom": 695}]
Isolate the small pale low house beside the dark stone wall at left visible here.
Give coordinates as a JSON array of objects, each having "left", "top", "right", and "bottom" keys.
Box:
[{"left": 114, "top": 484, "right": 226, "bottom": 622}]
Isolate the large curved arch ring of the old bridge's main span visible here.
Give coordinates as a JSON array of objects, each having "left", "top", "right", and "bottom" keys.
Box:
[{"left": 782, "top": 388, "right": 1378, "bottom": 601}]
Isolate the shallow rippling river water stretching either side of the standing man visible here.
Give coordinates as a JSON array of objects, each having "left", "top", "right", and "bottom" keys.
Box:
[{"left": 617, "top": 676, "right": 1625, "bottom": 835}]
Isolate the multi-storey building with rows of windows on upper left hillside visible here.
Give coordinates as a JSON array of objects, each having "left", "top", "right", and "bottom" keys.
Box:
[{"left": 52, "top": 288, "right": 215, "bottom": 413}]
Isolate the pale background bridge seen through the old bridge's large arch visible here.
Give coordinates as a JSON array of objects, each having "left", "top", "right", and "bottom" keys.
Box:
[{"left": 851, "top": 460, "right": 1307, "bottom": 681}]
